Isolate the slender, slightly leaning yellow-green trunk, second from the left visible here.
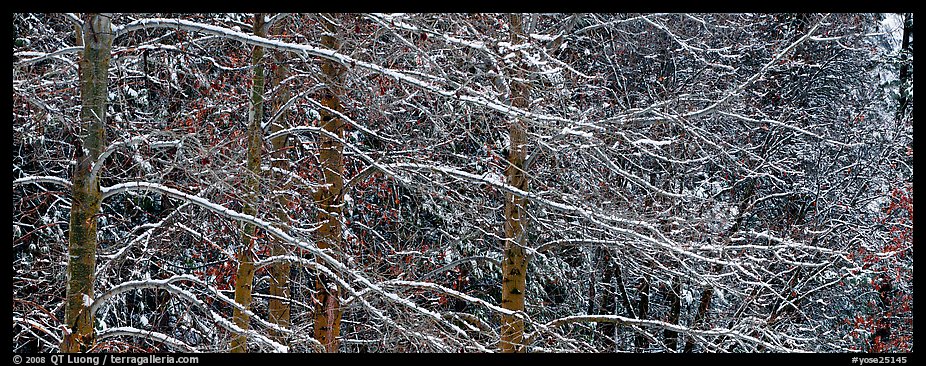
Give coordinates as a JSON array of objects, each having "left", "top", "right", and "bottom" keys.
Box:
[{"left": 230, "top": 13, "right": 266, "bottom": 353}]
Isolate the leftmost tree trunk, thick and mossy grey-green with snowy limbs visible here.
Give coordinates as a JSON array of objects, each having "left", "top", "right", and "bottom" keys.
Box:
[{"left": 61, "top": 14, "right": 113, "bottom": 352}]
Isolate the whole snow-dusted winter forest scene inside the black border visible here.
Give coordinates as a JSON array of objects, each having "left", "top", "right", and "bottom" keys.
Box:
[{"left": 12, "top": 13, "right": 913, "bottom": 353}]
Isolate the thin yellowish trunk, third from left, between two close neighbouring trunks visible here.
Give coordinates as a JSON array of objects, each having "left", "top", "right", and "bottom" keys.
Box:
[{"left": 268, "top": 21, "right": 292, "bottom": 345}]
